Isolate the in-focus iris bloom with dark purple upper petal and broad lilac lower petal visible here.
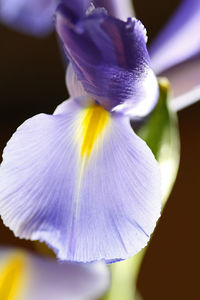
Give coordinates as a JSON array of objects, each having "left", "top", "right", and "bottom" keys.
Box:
[{"left": 0, "top": 0, "right": 161, "bottom": 263}]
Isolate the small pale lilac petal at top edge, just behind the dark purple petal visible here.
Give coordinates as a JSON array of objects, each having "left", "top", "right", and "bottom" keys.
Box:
[{"left": 93, "top": 0, "right": 134, "bottom": 21}]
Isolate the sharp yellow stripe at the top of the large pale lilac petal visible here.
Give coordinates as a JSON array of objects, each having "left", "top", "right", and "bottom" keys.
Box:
[{"left": 81, "top": 104, "right": 109, "bottom": 157}]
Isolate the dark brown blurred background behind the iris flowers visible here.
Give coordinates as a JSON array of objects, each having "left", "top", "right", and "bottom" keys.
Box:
[{"left": 0, "top": 0, "right": 200, "bottom": 300}]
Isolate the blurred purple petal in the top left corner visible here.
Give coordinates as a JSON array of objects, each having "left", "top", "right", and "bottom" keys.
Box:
[{"left": 0, "top": 0, "right": 59, "bottom": 35}]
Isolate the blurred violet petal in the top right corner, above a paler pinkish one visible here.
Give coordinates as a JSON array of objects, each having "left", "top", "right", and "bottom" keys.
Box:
[{"left": 149, "top": 0, "right": 200, "bottom": 74}]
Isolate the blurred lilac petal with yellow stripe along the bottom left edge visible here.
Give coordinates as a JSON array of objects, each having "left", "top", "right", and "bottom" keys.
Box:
[{"left": 0, "top": 247, "right": 109, "bottom": 300}]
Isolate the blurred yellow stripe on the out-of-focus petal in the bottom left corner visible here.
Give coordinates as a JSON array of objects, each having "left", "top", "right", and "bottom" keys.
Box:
[{"left": 0, "top": 253, "right": 25, "bottom": 300}]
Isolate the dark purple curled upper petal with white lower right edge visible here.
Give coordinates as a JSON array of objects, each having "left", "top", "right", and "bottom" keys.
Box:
[{"left": 56, "top": 1, "right": 158, "bottom": 116}]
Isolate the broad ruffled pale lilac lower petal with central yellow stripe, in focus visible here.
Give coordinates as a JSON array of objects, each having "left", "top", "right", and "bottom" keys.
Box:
[{"left": 0, "top": 98, "right": 161, "bottom": 262}]
